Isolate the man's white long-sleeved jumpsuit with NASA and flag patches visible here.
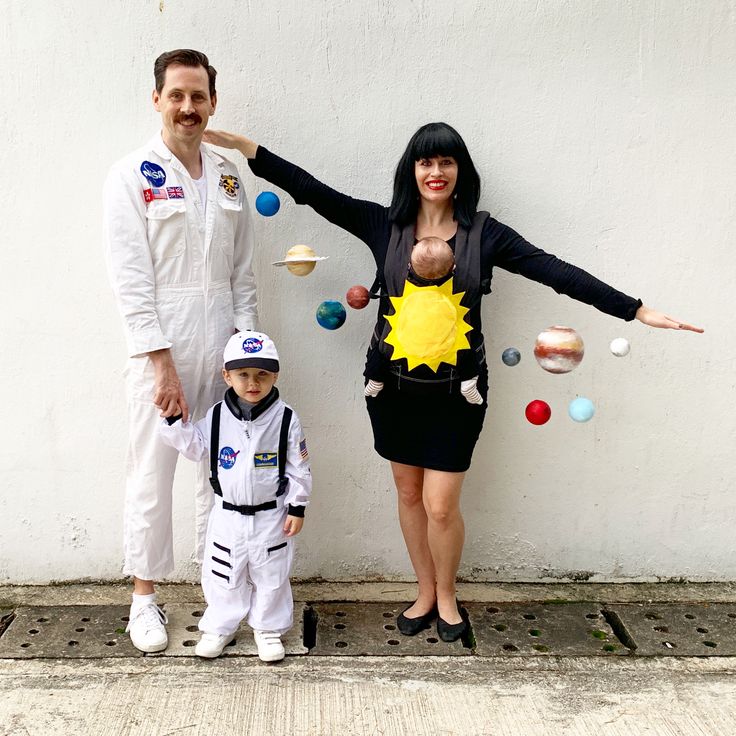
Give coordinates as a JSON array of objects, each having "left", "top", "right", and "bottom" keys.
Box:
[{"left": 104, "top": 134, "right": 257, "bottom": 580}]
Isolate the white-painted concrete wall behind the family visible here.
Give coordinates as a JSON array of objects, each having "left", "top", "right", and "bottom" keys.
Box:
[{"left": 0, "top": 0, "right": 736, "bottom": 583}]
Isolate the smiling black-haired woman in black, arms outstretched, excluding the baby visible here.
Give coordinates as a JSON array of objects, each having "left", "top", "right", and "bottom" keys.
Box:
[{"left": 204, "top": 123, "right": 702, "bottom": 641}]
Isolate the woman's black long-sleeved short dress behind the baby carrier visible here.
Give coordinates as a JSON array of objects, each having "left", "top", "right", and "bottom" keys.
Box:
[{"left": 248, "top": 146, "right": 641, "bottom": 472}]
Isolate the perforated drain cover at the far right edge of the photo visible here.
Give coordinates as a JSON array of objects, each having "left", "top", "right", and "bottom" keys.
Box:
[{"left": 606, "top": 603, "right": 736, "bottom": 657}]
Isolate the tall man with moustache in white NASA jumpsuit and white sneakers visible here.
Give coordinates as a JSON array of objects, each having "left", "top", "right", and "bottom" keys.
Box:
[{"left": 104, "top": 49, "right": 257, "bottom": 652}]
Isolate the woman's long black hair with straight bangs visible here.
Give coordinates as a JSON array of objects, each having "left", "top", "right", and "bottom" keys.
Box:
[{"left": 389, "top": 123, "right": 480, "bottom": 228}]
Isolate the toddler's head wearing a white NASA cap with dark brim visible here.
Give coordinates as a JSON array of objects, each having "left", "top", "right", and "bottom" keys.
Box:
[{"left": 222, "top": 330, "right": 279, "bottom": 404}]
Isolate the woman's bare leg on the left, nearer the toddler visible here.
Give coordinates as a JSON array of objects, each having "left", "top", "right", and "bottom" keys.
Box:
[{"left": 391, "top": 462, "right": 435, "bottom": 618}]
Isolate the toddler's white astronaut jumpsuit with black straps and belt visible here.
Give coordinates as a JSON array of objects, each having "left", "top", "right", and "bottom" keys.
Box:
[{"left": 159, "top": 389, "right": 312, "bottom": 635}]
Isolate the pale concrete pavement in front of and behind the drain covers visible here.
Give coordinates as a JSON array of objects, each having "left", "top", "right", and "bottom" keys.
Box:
[{"left": 0, "top": 583, "right": 736, "bottom": 736}]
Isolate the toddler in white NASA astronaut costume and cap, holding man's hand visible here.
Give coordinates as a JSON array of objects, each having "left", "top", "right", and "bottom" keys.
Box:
[{"left": 160, "top": 331, "right": 312, "bottom": 662}]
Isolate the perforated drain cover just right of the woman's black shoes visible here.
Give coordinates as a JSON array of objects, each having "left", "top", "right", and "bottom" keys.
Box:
[{"left": 467, "top": 603, "right": 629, "bottom": 657}]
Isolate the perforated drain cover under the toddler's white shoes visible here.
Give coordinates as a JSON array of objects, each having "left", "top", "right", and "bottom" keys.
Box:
[{"left": 152, "top": 603, "right": 308, "bottom": 657}]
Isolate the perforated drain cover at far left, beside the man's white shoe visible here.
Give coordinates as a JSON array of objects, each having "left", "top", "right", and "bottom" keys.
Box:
[{"left": 0, "top": 606, "right": 140, "bottom": 659}]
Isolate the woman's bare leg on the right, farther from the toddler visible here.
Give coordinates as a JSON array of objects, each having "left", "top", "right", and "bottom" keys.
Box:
[{"left": 422, "top": 469, "right": 465, "bottom": 624}]
